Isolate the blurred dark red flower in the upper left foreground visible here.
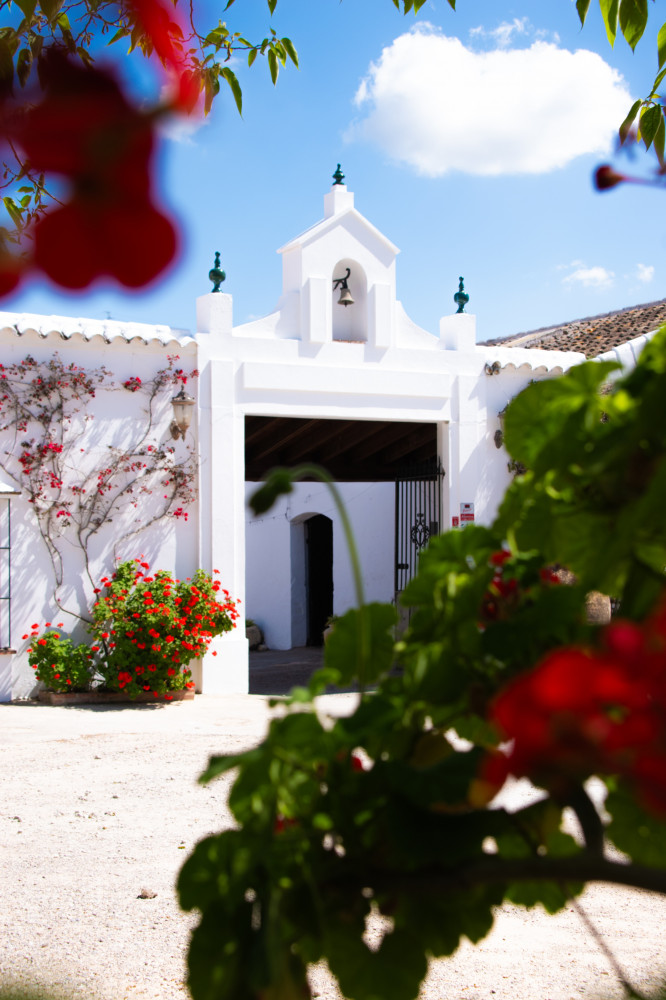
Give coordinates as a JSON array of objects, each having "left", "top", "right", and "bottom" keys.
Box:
[{"left": 6, "top": 48, "right": 176, "bottom": 291}]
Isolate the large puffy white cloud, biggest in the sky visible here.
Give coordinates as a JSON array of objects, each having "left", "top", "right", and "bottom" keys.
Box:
[{"left": 346, "top": 24, "right": 631, "bottom": 177}]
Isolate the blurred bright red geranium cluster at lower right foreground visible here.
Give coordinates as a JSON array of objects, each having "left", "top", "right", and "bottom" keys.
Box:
[{"left": 484, "top": 605, "right": 666, "bottom": 814}]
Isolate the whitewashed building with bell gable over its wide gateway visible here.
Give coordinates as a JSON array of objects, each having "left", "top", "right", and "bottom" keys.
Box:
[{"left": 0, "top": 173, "right": 652, "bottom": 700}]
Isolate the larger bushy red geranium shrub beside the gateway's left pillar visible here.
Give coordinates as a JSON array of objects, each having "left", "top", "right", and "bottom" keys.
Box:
[{"left": 90, "top": 559, "right": 238, "bottom": 699}]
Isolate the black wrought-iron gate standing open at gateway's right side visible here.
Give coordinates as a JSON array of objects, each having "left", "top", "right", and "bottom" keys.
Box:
[{"left": 395, "top": 461, "right": 444, "bottom": 598}]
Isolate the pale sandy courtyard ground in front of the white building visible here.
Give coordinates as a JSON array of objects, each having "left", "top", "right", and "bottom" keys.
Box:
[{"left": 0, "top": 672, "right": 666, "bottom": 1000}]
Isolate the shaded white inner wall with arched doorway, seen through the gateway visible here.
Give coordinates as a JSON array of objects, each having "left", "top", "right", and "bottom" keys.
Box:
[{"left": 245, "top": 482, "right": 395, "bottom": 649}]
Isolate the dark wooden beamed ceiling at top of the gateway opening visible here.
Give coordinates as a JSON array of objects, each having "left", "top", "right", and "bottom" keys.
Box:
[{"left": 245, "top": 417, "right": 437, "bottom": 483}]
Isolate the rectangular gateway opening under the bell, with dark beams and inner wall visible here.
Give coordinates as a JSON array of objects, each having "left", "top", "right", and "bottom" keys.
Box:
[{"left": 245, "top": 415, "right": 442, "bottom": 650}]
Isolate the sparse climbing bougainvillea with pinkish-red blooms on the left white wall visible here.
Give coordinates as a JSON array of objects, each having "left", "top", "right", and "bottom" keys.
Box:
[{"left": 0, "top": 354, "right": 198, "bottom": 610}]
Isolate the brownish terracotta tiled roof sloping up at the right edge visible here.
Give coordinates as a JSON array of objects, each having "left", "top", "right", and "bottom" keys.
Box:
[{"left": 485, "top": 299, "right": 666, "bottom": 358}]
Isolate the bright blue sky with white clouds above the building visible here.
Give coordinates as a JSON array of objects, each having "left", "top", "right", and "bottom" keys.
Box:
[{"left": 3, "top": 0, "right": 666, "bottom": 339}]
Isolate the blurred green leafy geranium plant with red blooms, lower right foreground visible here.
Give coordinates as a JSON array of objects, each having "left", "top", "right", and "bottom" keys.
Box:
[{"left": 178, "top": 332, "right": 666, "bottom": 1000}]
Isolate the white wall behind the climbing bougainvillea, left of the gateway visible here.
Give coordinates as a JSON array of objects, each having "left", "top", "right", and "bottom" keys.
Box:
[{"left": 0, "top": 321, "right": 201, "bottom": 701}]
